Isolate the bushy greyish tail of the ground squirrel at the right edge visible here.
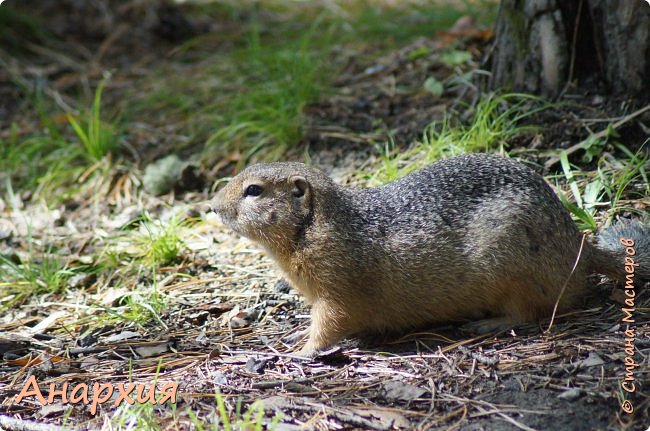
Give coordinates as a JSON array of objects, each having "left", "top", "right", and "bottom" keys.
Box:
[{"left": 590, "top": 220, "right": 650, "bottom": 284}]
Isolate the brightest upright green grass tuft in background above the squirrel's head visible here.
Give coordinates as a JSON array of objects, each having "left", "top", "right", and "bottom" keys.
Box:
[{"left": 206, "top": 18, "right": 328, "bottom": 159}]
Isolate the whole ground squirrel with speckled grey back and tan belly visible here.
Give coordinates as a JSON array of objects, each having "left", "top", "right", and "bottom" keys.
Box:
[{"left": 212, "top": 154, "right": 650, "bottom": 355}]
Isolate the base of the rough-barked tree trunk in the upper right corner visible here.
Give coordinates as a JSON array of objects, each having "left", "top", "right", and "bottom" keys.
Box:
[{"left": 489, "top": 0, "right": 650, "bottom": 99}]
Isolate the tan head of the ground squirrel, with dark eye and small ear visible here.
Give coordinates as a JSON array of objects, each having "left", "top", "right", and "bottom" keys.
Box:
[{"left": 212, "top": 162, "right": 331, "bottom": 250}]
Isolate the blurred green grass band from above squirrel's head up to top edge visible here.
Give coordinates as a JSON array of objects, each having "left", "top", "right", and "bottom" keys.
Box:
[{"left": 123, "top": 0, "right": 492, "bottom": 164}]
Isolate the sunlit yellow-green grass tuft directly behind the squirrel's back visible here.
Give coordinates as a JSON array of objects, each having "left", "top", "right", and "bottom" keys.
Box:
[{"left": 365, "top": 94, "right": 549, "bottom": 185}]
